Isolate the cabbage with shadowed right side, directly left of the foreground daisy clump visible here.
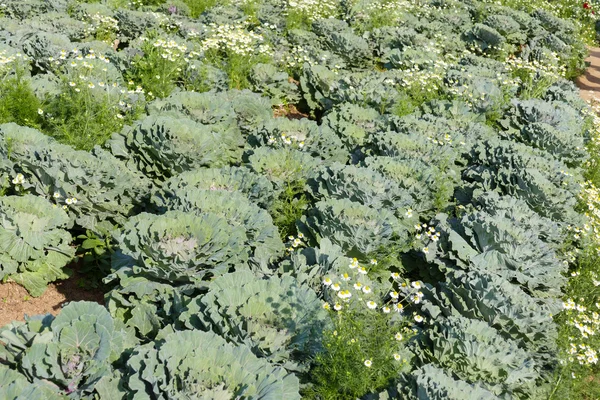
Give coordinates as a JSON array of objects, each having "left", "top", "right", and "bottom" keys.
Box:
[{"left": 181, "top": 270, "right": 329, "bottom": 369}]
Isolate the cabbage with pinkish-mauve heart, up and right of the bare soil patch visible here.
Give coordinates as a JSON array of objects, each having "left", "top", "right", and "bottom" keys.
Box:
[{"left": 112, "top": 211, "right": 248, "bottom": 285}]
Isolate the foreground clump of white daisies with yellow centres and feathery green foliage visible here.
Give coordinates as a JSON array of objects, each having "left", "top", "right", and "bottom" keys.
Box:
[{"left": 322, "top": 258, "right": 424, "bottom": 378}]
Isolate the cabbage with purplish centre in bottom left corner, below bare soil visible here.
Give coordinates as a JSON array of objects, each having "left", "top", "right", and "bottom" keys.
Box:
[{"left": 0, "top": 301, "right": 127, "bottom": 399}]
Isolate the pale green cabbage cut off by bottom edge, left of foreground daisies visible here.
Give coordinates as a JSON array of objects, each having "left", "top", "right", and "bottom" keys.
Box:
[{"left": 103, "top": 330, "right": 300, "bottom": 400}]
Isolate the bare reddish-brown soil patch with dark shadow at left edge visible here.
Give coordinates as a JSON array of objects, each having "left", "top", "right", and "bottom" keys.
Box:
[{"left": 0, "top": 262, "right": 104, "bottom": 327}]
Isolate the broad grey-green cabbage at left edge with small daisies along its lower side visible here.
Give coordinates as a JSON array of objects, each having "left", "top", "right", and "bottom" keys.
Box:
[{"left": 0, "top": 124, "right": 152, "bottom": 230}]
